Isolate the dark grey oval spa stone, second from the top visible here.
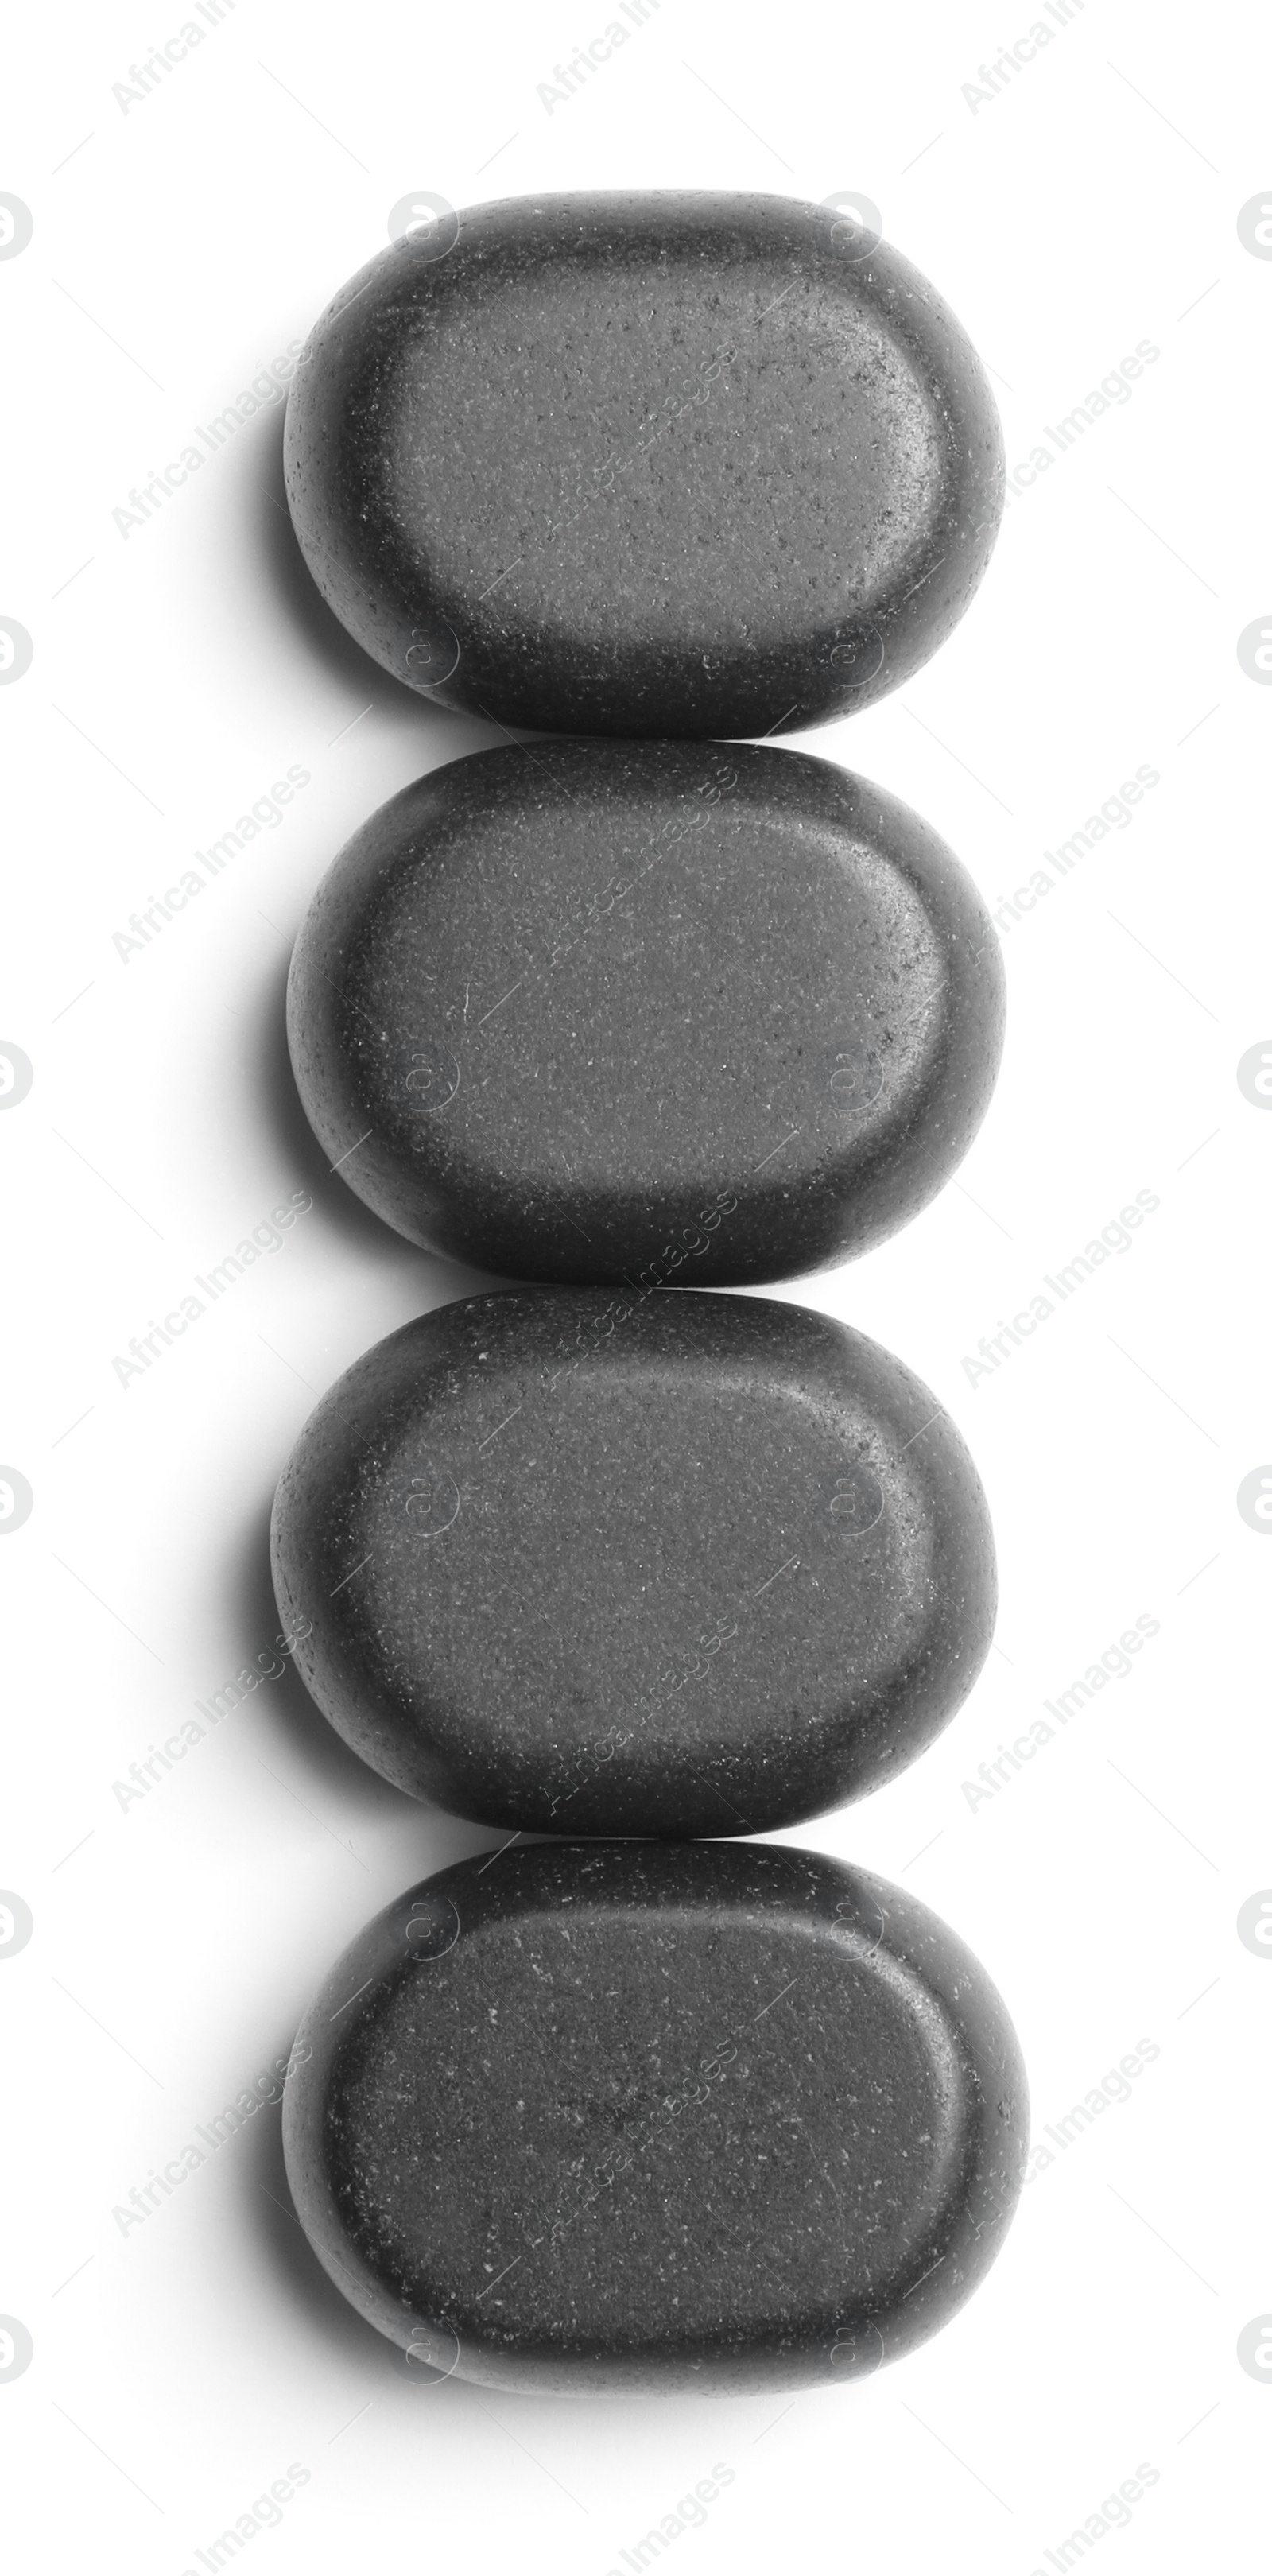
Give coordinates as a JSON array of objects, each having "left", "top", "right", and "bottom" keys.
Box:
[{"left": 289, "top": 739, "right": 1004, "bottom": 1286}]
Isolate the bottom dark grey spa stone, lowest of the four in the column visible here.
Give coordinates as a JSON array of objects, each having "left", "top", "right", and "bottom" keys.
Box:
[{"left": 283, "top": 1842, "right": 1027, "bottom": 2396}]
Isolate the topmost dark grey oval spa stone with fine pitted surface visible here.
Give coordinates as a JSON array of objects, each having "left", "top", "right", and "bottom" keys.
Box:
[{"left": 286, "top": 191, "right": 1004, "bottom": 734}]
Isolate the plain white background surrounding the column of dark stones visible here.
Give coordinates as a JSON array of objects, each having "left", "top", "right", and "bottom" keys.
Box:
[{"left": 0, "top": 0, "right": 1272, "bottom": 2576}]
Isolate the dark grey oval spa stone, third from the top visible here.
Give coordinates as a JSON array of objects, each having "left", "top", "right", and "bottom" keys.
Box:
[{"left": 273, "top": 1288, "right": 996, "bottom": 1837}]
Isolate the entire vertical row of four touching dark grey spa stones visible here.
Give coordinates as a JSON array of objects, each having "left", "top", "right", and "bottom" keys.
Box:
[{"left": 273, "top": 193, "right": 1025, "bottom": 2393}]
